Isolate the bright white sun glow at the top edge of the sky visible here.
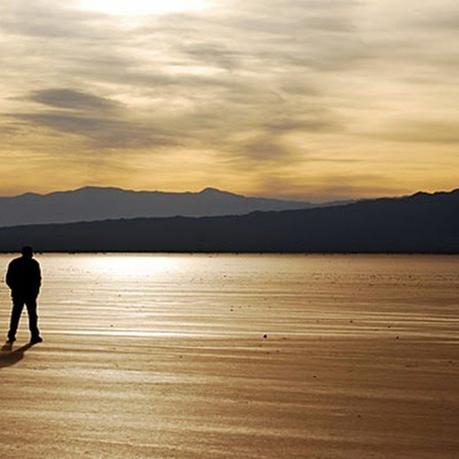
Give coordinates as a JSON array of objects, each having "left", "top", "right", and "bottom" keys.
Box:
[{"left": 77, "top": 0, "right": 210, "bottom": 16}]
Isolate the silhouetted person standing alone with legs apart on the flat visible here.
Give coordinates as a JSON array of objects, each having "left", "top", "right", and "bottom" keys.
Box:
[{"left": 6, "top": 247, "right": 43, "bottom": 344}]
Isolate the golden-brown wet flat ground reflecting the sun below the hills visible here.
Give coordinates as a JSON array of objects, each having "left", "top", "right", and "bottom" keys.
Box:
[{"left": 0, "top": 255, "right": 459, "bottom": 458}]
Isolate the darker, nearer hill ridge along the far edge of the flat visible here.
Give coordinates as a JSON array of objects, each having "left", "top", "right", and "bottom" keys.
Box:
[{"left": 0, "top": 190, "right": 459, "bottom": 253}]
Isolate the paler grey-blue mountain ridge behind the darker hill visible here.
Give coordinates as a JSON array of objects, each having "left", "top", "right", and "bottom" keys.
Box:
[{"left": 0, "top": 187, "right": 339, "bottom": 227}]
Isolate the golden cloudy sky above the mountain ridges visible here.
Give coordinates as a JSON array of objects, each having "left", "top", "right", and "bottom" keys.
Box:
[{"left": 0, "top": 0, "right": 459, "bottom": 201}]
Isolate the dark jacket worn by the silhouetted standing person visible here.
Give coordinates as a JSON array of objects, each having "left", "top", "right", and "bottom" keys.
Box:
[{"left": 6, "top": 257, "right": 41, "bottom": 297}]
